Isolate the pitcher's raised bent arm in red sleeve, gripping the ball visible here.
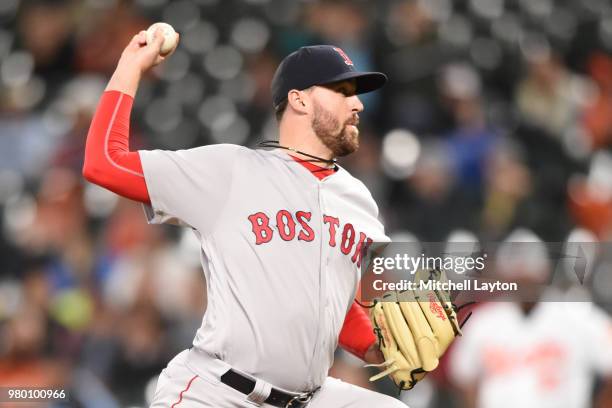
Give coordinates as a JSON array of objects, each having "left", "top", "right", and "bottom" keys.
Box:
[{"left": 83, "top": 30, "right": 174, "bottom": 203}]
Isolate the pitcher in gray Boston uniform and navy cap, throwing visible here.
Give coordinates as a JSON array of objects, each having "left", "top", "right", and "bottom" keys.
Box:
[{"left": 83, "top": 32, "right": 405, "bottom": 408}]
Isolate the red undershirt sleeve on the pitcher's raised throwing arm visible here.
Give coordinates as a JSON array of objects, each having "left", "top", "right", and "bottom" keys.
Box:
[{"left": 83, "top": 91, "right": 151, "bottom": 204}]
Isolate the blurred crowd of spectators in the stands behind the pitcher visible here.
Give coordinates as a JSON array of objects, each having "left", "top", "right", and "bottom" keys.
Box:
[{"left": 0, "top": 0, "right": 612, "bottom": 407}]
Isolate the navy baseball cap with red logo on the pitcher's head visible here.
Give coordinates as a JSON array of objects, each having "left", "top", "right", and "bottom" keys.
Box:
[{"left": 272, "top": 45, "right": 387, "bottom": 109}]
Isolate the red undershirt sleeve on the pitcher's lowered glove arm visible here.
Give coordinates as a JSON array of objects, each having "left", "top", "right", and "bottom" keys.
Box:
[{"left": 338, "top": 302, "right": 376, "bottom": 360}]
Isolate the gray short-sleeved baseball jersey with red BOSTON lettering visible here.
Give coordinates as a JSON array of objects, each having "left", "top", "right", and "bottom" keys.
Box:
[{"left": 140, "top": 145, "right": 388, "bottom": 391}]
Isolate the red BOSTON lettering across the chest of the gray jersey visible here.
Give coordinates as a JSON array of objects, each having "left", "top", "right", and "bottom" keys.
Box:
[{"left": 249, "top": 210, "right": 372, "bottom": 267}]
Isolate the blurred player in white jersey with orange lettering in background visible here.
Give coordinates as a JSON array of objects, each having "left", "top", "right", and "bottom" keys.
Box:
[{"left": 449, "top": 231, "right": 612, "bottom": 408}]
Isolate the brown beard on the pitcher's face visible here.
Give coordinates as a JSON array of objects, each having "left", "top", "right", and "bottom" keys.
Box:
[{"left": 312, "top": 102, "right": 359, "bottom": 157}]
